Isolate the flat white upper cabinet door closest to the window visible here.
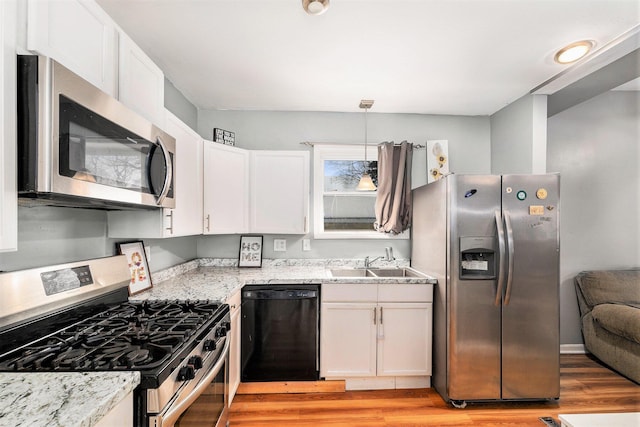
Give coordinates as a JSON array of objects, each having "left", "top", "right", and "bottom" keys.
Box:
[{"left": 250, "top": 151, "right": 309, "bottom": 234}]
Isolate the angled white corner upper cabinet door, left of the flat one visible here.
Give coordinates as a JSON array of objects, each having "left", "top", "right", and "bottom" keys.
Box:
[{"left": 204, "top": 141, "right": 249, "bottom": 234}]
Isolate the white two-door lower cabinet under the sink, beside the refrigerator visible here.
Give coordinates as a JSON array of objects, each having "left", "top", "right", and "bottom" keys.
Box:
[{"left": 320, "top": 284, "right": 433, "bottom": 389}]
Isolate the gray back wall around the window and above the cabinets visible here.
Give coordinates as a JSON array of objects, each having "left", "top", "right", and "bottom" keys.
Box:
[{"left": 198, "top": 110, "right": 491, "bottom": 259}]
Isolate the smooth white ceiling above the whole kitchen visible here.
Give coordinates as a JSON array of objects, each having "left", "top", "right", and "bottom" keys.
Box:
[{"left": 97, "top": 0, "right": 640, "bottom": 115}]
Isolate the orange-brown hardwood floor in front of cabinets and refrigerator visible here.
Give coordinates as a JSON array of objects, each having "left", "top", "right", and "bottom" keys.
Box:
[{"left": 230, "top": 355, "right": 640, "bottom": 427}]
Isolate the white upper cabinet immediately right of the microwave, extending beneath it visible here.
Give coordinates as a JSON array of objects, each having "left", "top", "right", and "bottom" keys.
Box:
[{"left": 107, "top": 111, "right": 203, "bottom": 238}]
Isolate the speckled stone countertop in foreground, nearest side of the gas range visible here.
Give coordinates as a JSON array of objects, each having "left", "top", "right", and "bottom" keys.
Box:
[{"left": 0, "top": 372, "right": 140, "bottom": 427}]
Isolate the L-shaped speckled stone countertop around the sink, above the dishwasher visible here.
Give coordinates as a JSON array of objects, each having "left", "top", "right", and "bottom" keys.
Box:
[{"left": 130, "top": 258, "right": 435, "bottom": 302}]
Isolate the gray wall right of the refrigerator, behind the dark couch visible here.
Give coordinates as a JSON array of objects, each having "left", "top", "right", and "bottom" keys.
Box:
[{"left": 547, "top": 91, "right": 640, "bottom": 343}]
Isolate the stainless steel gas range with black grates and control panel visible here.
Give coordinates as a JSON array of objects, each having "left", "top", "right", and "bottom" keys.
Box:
[{"left": 0, "top": 256, "right": 231, "bottom": 427}]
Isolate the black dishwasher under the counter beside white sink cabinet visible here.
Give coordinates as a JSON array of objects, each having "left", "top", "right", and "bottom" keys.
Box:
[{"left": 240, "top": 284, "right": 320, "bottom": 382}]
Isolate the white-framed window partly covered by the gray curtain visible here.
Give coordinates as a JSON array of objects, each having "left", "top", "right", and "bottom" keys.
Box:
[{"left": 313, "top": 145, "right": 408, "bottom": 239}]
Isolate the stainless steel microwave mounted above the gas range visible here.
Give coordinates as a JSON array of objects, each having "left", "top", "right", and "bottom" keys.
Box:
[{"left": 17, "top": 55, "right": 176, "bottom": 209}]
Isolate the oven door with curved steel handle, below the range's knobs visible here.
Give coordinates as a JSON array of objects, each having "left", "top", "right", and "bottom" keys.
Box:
[{"left": 149, "top": 335, "right": 230, "bottom": 427}]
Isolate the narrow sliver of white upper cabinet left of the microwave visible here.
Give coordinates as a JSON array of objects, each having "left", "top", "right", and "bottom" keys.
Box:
[{"left": 0, "top": 0, "right": 18, "bottom": 252}]
